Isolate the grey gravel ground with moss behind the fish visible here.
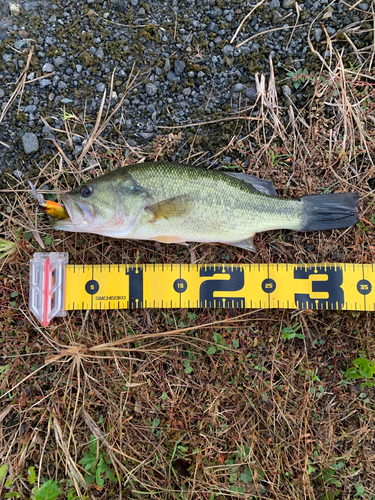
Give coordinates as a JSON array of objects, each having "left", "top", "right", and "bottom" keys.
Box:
[{"left": 0, "top": 0, "right": 372, "bottom": 177}]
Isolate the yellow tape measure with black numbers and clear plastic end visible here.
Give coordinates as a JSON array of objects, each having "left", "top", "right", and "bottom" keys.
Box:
[{"left": 30, "top": 253, "right": 375, "bottom": 324}]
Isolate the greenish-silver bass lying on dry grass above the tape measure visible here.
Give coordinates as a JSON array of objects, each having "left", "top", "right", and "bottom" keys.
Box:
[{"left": 52, "top": 162, "right": 358, "bottom": 252}]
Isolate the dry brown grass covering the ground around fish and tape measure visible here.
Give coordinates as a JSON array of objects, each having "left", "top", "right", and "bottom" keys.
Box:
[{"left": 0, "top": 30, "right": 375, "bottom": 500}]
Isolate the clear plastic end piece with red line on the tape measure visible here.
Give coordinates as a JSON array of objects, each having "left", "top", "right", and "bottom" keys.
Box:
[{"left": 29, "top": 252, "right": 69, "bottom": 326}]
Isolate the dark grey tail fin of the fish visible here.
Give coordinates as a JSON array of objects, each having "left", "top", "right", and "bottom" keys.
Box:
[{"left": 300, "top": 193, "right": 358, "bottom": 231}]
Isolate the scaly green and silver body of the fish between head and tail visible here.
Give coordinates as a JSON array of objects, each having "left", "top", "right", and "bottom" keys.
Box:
[{"left": 128, "top": 163, "right": 302, "bottom": 242}]
